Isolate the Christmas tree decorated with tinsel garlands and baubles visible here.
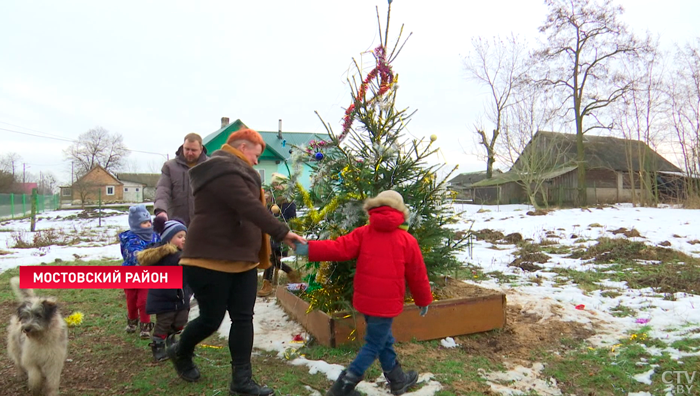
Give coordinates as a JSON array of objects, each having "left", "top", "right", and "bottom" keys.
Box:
[{"left": 278, "top": 1, "right": 466, "bottom": 313}]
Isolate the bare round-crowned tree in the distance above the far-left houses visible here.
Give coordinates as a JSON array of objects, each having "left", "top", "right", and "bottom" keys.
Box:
[{"left": 65, "top": 126, "right": 129, "bottom": 178}]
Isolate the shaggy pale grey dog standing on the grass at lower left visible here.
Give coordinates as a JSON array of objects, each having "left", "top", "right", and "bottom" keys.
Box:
[{"left": 7, "top": 277, "right": 68, "bottom": 396}]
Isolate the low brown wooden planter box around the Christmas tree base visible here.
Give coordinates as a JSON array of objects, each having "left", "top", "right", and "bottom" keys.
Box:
[{"left": 276, "top": 286, "right": 506, "bottom": 347}]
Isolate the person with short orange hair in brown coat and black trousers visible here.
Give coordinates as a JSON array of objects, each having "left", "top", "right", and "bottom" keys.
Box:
[{"left": 167, "top": 129, "right": 306, "bottom": 395}]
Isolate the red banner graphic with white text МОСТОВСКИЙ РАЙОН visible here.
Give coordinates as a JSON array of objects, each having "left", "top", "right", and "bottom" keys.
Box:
[{"left": 19, "top": 265, "right": 182, "bottom": 289}]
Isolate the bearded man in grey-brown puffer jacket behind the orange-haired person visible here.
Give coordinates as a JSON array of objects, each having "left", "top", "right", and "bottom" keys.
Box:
[{"left": 154, "top": 133, "right": 209, "bottom": 226}]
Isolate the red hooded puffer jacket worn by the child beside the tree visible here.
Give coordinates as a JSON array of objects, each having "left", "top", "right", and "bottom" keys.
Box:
[{"left": 309, "top": 206, "right": 433, "bottom": 318}]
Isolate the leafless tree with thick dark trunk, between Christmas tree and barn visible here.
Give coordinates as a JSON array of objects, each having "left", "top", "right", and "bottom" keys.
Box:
[{"left": 464, "top": 35, "right": 526, "bottom": 178}]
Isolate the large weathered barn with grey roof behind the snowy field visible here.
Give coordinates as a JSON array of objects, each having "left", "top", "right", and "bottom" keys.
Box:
[{"left": 471, "top": 131, "right": 682, "bottom": 206}]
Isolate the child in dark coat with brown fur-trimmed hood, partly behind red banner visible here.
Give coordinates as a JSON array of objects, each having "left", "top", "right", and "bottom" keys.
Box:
[{"left": 137, "top": 217, "right": 192, "bottom": 362}]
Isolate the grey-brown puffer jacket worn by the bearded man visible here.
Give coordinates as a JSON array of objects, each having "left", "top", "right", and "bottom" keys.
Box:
[{"left": 154, "top": 146, "right": 209, "bottom": 225}]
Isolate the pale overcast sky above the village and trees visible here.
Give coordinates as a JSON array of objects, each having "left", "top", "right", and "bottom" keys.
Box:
[{"left": 0, "top": 0, "right": 700, "bottom": 181}]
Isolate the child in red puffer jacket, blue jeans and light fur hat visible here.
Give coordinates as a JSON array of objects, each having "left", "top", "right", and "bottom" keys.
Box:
[{"left": 296, "top": 190, "right": 433, "bottom": 396}]
